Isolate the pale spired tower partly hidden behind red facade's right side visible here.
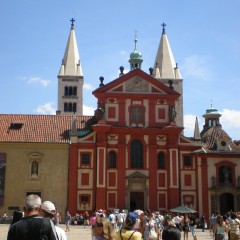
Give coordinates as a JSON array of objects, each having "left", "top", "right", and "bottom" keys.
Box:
[{"left": 153, "top": 23, "right": 183, "bottom": 127}]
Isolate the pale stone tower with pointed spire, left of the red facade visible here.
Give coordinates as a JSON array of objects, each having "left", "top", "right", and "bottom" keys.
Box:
[{"left": 56, "top": 18, "right": 83, "bottom": 116}]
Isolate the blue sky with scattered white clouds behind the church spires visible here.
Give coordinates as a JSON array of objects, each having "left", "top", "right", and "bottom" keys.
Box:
[{"left": 0, "top": 0, "right": 240, "bottom": 140}]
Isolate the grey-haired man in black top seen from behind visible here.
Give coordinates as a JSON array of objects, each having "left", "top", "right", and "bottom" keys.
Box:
[{"left": 7, "top": 194, "right": 57, "bottom": 240}]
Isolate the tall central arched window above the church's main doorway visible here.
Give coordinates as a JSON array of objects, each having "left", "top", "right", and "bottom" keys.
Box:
[{"left": 130, "top": 140, "right": 143, "bottom": 168}]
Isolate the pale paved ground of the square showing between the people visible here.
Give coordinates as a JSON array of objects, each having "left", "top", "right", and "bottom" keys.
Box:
[{"left": 0, "top": 224, "right": 213, "bottom": 240}]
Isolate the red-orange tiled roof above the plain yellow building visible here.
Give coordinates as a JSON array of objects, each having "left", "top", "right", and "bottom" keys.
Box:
[{"left": 0, "top": 114, "right": 92, "bottom": 143}]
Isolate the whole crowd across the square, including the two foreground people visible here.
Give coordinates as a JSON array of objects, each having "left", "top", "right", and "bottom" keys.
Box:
[{"left": 4, "top": 194, "right": 240, "bottom": 240}]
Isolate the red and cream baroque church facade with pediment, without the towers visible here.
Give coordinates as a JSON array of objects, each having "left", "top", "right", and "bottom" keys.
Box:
[{"left": 69, "top": 68, "right": 199, "bottom": 216}]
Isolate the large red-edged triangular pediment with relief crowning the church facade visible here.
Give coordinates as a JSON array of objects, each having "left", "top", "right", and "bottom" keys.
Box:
[{"left": 93, "top": 69, "right": 179, "bottom": 95}]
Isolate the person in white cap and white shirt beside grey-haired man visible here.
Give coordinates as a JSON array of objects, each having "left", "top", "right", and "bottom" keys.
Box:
[{"left": 40, "top": 201, "right": 67, "bottom": 240}]
